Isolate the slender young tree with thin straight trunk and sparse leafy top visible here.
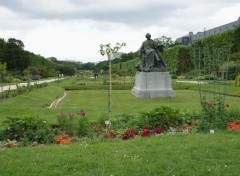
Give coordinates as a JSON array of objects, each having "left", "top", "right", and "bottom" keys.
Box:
[{"left": 99, "top": 43, "right": 126, "bottom": 132}]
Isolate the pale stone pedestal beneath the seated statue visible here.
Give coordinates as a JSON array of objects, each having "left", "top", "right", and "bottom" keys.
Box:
[{"left": 131, "top": 72, "right": 176, "bottom": 98}]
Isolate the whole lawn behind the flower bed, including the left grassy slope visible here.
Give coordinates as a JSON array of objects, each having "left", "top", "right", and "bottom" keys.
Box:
[{"left": 0, "top": 83, "right": 240, "bottom": 122}]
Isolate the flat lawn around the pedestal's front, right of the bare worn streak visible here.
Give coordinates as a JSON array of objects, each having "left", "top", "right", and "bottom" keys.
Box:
[{"left": 59, "top": 90, "right": 200, "bottom": 117}]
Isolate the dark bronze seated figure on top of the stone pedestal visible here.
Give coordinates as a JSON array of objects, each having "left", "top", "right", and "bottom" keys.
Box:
[{"left": 136, "top": 33, "right": 167, "bottom": 72}]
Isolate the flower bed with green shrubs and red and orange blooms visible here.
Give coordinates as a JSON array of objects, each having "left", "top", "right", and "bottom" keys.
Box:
[{"left": 0, "top": 106, "right": 240, "bottom": 147}]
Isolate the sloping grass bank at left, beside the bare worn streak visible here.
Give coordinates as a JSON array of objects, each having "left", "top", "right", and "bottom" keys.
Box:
[{"left": 0, "top": 84, "right": 64, "bottom": 122}]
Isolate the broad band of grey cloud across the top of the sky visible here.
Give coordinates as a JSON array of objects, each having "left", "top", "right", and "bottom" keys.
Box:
[{"left": 0, "top": 0, "right": 239, "bottom": 30}]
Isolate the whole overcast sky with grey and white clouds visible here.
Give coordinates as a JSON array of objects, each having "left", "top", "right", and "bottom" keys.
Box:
[{"left": 0, "top": 0, "right": 240, "bottom": 63}]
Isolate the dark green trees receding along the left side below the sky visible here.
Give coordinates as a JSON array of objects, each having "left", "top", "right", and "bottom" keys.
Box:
[{"left": 0, "top": 38, "right": 83, "bottom": 77}]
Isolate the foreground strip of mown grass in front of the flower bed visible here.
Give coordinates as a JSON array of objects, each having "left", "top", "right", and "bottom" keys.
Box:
[{"left": 0, "top": 132, "right": 240, "bottom": 176}]
